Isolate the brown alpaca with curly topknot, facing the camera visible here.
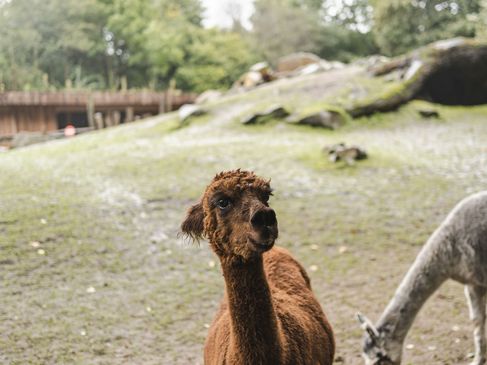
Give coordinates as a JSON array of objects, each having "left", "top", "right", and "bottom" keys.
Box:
[{"left": 181, "top": 170, "right": 335, "bottom": 365}]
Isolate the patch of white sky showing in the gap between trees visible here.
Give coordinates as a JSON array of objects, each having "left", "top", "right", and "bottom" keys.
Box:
[{"left": 201, "top": 0, "right": 254, "bottom": 29}]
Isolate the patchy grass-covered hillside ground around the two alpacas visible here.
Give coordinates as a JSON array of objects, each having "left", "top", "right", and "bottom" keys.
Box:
[{"left": 0, "top": 75, "right": 487, "bottom": 364}]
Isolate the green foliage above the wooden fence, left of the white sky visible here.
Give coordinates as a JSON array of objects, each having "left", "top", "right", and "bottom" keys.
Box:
[{"left": 0, "top": 0, "right": 255, "bottom": 91}]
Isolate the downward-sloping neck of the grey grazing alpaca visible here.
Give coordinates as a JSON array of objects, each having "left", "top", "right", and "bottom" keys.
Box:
[{"left": 377, "top": 231, "right": 451, "bottom": 348}]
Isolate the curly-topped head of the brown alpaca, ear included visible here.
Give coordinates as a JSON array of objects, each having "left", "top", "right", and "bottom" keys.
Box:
[{"left": 181, "top": 170, "right": 278, "bottom": 261}]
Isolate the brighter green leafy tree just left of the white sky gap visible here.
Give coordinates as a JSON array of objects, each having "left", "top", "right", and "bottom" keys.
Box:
[{"left": 108, "top": 0, "right": 253, "bottom": 91}]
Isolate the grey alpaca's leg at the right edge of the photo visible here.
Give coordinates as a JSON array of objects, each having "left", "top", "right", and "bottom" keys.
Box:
[{"left": 465, "top": 285, "right": 487, "bottom": 365}]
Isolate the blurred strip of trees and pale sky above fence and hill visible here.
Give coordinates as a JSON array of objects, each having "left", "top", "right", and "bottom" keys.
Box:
[{"left": 0, "top": 0, "right": 487, "bottom": 92}]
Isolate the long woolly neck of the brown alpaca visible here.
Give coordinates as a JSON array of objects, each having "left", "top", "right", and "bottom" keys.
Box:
[{"left": 222, "top": 256, "right": 281, "bottom": 364}]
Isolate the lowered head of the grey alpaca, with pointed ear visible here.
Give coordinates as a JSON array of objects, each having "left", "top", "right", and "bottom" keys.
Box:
[{"left": 357, "top": 313, "right": 402, "bottom": 365}]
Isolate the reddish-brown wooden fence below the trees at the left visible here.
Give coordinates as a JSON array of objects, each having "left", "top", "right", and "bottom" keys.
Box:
[{"left": 0, "top": 91, "right": 196, "bottom": 136}]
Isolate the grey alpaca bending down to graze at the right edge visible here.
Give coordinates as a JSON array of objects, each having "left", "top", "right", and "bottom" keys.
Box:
[{"left": 358, "top": 191, "right": 487, "bottom": 365}]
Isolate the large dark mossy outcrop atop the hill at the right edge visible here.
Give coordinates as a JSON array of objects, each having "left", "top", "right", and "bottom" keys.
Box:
[{"left": 347, "top": 38, "right": 487, "bottom": 117}]
